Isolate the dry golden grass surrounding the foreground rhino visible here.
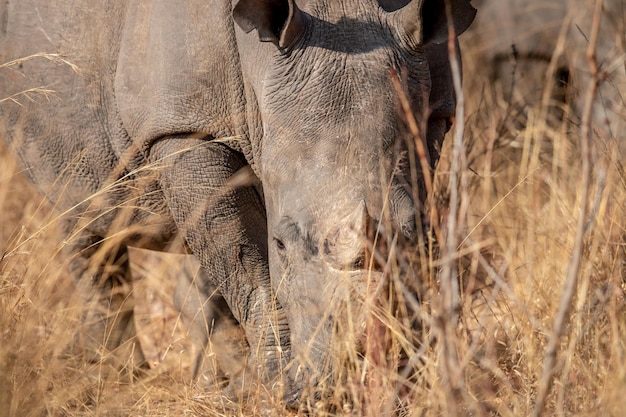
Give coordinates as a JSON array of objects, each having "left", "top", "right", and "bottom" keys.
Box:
[{"left": 0, "top": 18, "right": 626, "bottom": 416}]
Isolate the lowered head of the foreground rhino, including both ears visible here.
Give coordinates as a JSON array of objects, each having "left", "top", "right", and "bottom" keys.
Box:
[{"left": 233, "top": 0, "right": 475, "bottom": 401}]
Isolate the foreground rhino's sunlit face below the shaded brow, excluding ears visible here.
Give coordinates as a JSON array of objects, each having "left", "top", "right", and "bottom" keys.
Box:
[{"left": 261, "top": 21, "right": 422, "bottom": 386}]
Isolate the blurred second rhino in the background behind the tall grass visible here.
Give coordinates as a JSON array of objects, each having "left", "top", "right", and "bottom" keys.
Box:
[{"left": 464, "top": 0, "right": 626, "bottom": 154}]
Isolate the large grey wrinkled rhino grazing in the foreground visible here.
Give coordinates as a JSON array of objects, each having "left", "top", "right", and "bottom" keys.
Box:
[{"left": 0, "top": 0, "right": 474, "bottom": 401}]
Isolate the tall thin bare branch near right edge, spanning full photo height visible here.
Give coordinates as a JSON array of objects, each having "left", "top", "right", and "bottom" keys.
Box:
[{"left": 533, "top": 0, "right": 603, "bottom": 417}]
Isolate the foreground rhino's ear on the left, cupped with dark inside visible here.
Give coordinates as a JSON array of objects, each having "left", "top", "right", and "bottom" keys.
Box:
[{"left": 233, "top": 0, "right": 304, "bottom": 48}]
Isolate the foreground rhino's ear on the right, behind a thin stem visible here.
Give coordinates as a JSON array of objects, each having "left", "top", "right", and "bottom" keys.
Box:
[{"left": 393, "top": 0, "right": 476, "bottom": 45}]
